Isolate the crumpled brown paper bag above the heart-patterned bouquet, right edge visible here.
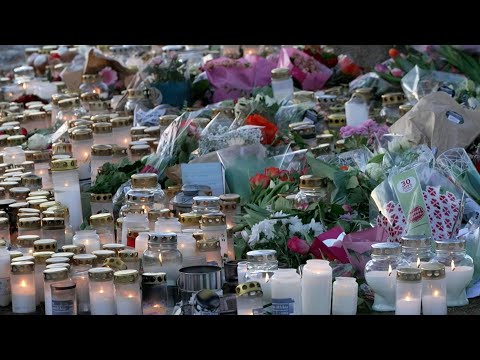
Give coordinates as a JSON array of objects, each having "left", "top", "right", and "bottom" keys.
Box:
[{"left": 390, "top": 91, "right": 480, "bottom": 154}]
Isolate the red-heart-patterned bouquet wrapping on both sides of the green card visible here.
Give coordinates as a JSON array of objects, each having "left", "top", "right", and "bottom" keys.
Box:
[{"left": 377, "top": 186, "right": 461, "bottom": 242}]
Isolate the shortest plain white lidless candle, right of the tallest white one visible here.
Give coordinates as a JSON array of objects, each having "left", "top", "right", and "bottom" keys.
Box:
[{"left": 332, "top": 277, "right": 358, "bottom": 315}]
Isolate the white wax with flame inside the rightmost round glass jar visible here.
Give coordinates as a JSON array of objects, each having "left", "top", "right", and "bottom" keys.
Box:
[{"left": 445, "top": 260, "right": 473, "bottom": 306}]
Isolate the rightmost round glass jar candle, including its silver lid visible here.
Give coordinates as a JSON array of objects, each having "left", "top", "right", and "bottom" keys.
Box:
[{"left": 432, "top": 239, "right": 473, "bottom": 306}]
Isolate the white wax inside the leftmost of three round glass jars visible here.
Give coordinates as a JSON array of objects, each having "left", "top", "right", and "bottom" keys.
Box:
[{"left": 365, "top": 270, "right": 397, "bottom": 311}]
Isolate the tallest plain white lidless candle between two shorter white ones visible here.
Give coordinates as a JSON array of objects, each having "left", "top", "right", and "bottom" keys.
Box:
[{"left": 302, "top": 260, "right": 332, "bottom": 315}]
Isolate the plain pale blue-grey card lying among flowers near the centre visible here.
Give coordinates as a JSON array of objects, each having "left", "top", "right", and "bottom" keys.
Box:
[{"left": 182, "top": 162, "right": 225, "bottom": 196}]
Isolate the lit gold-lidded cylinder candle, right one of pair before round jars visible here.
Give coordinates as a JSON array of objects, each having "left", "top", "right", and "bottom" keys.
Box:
[{"left": 421, "top": 263, "right": 447, "bottom": 315}]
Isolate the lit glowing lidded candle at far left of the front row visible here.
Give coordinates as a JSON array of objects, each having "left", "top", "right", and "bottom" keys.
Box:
[{"left": 10, "top": 261, "right": 36, "bottom": 314}]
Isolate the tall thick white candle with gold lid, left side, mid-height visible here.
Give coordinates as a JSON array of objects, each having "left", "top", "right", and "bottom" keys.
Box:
[{"left": 52, "top": 159, "right": 83, "bottom": 231}]
